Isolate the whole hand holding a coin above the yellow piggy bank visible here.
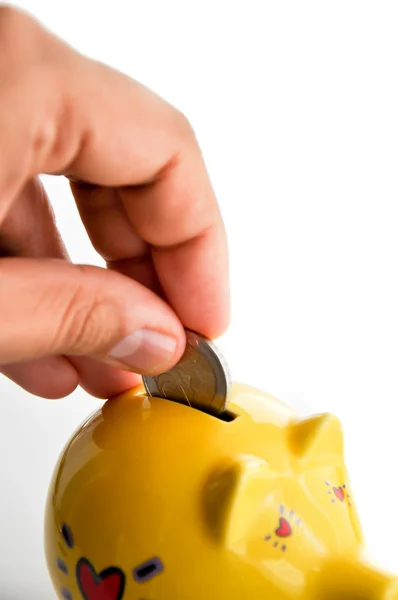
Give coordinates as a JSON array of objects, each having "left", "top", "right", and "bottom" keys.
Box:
[{"left": 0, "top": 6, "right": 229, "bottom": 398}]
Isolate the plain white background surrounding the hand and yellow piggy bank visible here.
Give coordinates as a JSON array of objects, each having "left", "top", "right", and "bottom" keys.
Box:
[{"left": 0, "top": 0, "right": 398, "bottom": 600}]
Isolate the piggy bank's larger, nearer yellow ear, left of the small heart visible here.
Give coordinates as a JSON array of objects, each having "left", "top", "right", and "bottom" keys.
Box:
[{"left": 202, "top": 455, "right": 275, "bottom": 546}]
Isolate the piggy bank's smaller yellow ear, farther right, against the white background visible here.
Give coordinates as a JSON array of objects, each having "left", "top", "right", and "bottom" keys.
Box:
[{"left": 287, "top": 414, "right": 344, "bottom": 464}]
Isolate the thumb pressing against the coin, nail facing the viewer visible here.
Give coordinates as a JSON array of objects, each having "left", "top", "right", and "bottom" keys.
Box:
[{"left": 0, "top": 258, "right": 185, "bottom": 374}]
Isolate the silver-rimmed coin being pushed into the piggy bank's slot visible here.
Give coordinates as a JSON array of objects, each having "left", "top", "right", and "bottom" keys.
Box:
[{"left": 142, "top": 331, "right": 231, "bottom": 415}]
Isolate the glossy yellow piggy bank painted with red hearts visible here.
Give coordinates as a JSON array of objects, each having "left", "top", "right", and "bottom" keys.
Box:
[{"left": 45, "top": 384, "right": 398, "bottom": 600}]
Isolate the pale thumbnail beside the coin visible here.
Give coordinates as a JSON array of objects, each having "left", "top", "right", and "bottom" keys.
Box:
[{"left": 109, "top": 329, "right": 177, "bottom": 374}]
